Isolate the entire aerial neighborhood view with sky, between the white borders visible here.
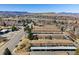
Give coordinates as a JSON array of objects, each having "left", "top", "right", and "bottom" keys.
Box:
[{"left": 0, "top": 4, "right": 79, "bottom": 55}]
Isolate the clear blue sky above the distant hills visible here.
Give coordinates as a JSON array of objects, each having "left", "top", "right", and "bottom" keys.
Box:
[{"left": 0, "top": 4, "right": 79, "bottom": 13}]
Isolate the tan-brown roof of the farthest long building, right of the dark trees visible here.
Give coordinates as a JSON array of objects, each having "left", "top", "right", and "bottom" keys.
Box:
[{"left": 33, "top": 25, "right": 61, "bottom": 33}]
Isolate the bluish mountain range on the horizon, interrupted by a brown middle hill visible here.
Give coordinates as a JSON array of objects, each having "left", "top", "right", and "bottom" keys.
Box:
[{"left": 0, "top": 11, "right": 79, "bottom": 16}]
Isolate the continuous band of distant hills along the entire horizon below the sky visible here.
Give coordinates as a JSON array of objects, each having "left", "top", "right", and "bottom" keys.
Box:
[{"left": 0, "top": 11, "right": 79, "bottom": 17}]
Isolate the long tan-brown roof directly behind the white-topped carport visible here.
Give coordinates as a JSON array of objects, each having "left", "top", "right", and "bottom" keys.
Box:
[{"left": 30, "top": 39, "right": 73, "bottom": 45}]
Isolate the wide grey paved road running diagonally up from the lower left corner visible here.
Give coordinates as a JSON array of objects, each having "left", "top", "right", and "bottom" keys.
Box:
[{"left": 0, "top": 29, "right": 24, "bottom": 55}]
